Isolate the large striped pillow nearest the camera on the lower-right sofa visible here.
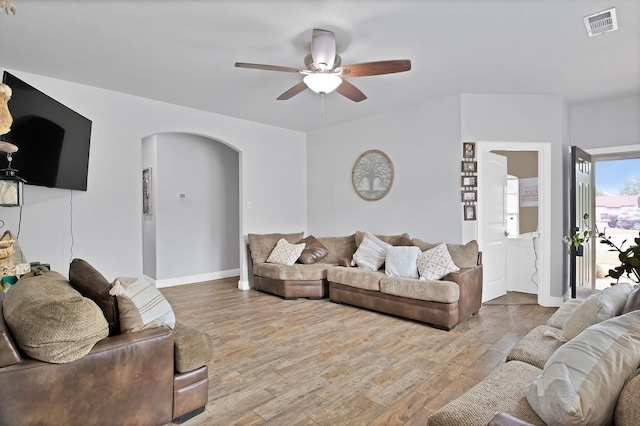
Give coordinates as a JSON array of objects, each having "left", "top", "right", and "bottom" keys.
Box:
[{"left": 526, "top": 311, "right": 640, "bottom": 425}]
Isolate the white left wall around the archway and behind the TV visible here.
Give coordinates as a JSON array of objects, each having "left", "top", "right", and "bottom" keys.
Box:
[{"left": 0, "top": 69, "right": 307, "bottom": 286}]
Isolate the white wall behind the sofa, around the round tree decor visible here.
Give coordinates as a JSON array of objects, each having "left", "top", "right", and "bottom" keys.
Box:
[{"left": 307, "top": 96, "right": 462, "bottom": 242}]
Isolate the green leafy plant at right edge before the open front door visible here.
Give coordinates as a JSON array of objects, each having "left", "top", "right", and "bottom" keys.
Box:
[{"left": 562, "top": 213, "right": 640, "bottom": 283}]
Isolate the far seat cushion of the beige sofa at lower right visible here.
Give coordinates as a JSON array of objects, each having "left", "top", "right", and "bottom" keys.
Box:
[{"left": 507, "top": 325, "right": 562, "bottom": 368}]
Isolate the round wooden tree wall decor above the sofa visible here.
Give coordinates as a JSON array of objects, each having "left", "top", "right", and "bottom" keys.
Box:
[{"left": 351, "top": 149, "right": 393, "bottom": 201}]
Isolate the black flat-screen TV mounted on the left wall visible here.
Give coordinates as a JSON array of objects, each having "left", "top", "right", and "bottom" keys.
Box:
[{"left": 0, "top": 71, "right": 91, "bottom": 191}]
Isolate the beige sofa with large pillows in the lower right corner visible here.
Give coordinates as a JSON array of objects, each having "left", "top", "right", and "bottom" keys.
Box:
[{"left": 428, "top": 282, "right": 640, "bottom": 426}]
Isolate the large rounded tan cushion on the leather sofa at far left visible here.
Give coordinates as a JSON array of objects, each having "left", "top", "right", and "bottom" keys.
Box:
[{"left": 3, "top": 272, "right": 109, "bottom": 364}]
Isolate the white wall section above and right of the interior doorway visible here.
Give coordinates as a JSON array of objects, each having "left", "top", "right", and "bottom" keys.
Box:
[{"left": 461, "top": 94, "right": 565, "bottom": 297}]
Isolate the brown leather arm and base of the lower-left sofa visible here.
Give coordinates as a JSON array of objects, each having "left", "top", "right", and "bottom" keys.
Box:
[{"left": 0, "top": 291, "right": 209, "bottom": 425}]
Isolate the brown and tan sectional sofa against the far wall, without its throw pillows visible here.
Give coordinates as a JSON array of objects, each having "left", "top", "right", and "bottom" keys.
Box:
[{"left": 248, "top": 231, "right": 482, "bottom": 330}]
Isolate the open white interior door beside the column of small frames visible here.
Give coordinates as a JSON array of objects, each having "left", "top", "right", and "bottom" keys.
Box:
[{"left": 478, "top": 150, "right": 507, "bottom": 302}]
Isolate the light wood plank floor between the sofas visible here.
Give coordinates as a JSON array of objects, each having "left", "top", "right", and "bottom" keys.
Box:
[{"left": 162, "top": 278, "right": 555, "bottom": 426}]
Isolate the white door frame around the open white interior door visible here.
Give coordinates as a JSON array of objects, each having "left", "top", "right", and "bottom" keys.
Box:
[{"left": 461, "top": 141, "right": 558, "bottom": 307}]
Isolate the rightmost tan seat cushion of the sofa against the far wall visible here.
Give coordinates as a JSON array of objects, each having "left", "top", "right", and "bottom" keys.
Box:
[{"left": 380, "top": 276, "right": 460, "bottom": 303}]
